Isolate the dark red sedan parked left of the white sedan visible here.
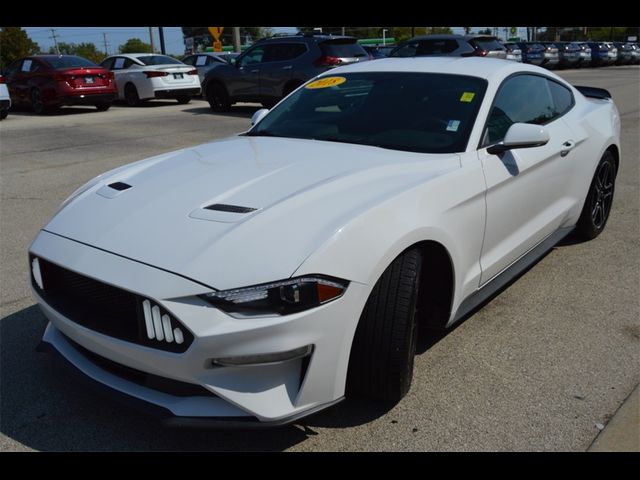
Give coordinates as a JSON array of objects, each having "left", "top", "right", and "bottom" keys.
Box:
[{"left": 5, "top": 55, "right": 117, "bottom": 114}]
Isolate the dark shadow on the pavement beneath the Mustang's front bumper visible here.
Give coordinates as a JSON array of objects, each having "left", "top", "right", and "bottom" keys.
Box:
[{"left": 0, "top": 305, "right": 313, "bottom": 451}]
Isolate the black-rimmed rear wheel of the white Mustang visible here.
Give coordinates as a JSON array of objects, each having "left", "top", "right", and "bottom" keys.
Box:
[{"left": 576, "top": 151, "right": 617, "bottom": 240}]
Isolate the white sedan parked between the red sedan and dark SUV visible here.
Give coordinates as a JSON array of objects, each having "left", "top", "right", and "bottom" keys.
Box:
[{"left": 100, "top": 53, "right": 201, "bottom": 106}]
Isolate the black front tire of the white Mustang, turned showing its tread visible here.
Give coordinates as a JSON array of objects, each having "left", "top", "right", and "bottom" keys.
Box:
[{"left": 347, "top": 249, "right": 422, "bottom": 402}]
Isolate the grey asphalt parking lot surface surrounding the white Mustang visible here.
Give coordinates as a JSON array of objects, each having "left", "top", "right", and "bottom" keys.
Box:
[{"left": 0, "top": 66, "right": 640, "bottom": 451}]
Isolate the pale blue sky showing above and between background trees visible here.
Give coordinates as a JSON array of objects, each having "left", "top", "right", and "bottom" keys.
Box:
[{"left": 23, "top": 27, "right": 526, "bottom": 55}]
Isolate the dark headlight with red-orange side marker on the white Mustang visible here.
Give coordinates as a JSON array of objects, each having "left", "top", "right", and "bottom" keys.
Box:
[{"left": 200, "top": 275, "right": 348, "bottom": 317}]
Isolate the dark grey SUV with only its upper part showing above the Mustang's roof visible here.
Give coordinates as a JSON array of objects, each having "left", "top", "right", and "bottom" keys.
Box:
[{"left": 389, "top": 34, "right": 507, "bottom": 58}]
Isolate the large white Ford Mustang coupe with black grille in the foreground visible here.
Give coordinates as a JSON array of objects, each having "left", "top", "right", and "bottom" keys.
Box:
[{"left": 29, "top": 57, "right": 620, "bottom": 425}]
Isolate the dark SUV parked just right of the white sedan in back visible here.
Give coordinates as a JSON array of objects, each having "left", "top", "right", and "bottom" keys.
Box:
[{"left": 202, "top": 34, "right": 369, "bottom": 112}]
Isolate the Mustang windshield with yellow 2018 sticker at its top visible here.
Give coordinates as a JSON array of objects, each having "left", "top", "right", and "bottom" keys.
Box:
[{"left": 247, "top": 72, "right": 487, "bottom": 153}]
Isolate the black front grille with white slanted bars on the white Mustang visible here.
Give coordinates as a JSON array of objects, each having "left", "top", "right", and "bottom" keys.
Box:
[{"left": 30, "top": 256, "right": 193, "bottom": 353}]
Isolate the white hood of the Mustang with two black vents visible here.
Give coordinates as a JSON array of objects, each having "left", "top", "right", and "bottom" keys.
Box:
[{"left": 45, "top": 136, "right": 460, "bottom": 289}]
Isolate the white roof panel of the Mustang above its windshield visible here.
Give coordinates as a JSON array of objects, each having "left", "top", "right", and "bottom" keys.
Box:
[{"left": 323, "top": 56, "right": 566, "bottom": 83}]
